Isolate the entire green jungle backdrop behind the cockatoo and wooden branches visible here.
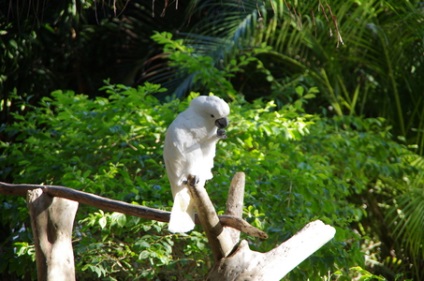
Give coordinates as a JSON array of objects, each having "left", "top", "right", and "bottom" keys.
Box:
[{"left": 0, "top": 0, "right": 424, "bottom": 280}]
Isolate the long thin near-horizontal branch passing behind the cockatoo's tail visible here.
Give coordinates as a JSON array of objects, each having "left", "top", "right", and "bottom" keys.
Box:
[{"left": 0, "top": 182, "right": 267, "bottom": 238}]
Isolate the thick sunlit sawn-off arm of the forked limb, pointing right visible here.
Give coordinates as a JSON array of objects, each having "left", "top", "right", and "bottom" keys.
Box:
[{"left": 207, "top": 220, "right": 336, "bottom": 281}]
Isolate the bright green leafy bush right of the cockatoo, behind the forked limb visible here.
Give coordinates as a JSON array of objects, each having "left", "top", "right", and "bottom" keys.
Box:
[{"left": 222, "top": 102, "right": 416, "bottom": 280}]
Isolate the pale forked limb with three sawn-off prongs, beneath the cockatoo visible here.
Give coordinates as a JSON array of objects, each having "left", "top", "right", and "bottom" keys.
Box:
[{"left": 187, "top": 173, "right": 335, "bottom": 281}]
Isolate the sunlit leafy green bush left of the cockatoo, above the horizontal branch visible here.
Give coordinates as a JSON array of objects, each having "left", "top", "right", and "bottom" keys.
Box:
[{"left": 3, "top": 82, "right": 166, "bottom": 195}]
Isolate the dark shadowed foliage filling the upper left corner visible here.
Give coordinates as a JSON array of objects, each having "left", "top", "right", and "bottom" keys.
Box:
[{"left": 0, "top": 0, "right": 171, "bottom": 123}]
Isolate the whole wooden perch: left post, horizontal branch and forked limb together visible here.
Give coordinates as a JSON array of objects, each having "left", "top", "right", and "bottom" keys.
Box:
[{"left": 0, "top": 173, "right": 335, "bottom": 281}]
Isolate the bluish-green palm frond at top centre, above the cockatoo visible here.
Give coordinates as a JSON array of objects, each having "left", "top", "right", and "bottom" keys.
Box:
[{"left": 141, "top": 0, "right": 259, "bottom": 97}]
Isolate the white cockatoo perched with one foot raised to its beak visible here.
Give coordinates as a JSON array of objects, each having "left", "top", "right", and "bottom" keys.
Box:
[{"left": 163, "top": 96, "right": 230, "bottom": 233}]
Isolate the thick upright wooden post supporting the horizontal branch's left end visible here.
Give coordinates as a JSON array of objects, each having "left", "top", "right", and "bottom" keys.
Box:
[{"left": 27, "top": 189, "right": 78, "bottom": 281}]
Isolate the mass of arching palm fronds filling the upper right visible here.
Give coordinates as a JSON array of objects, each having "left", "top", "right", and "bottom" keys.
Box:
[{"left": 151, "top": 0, "right": 424, "bottom": 154}]
